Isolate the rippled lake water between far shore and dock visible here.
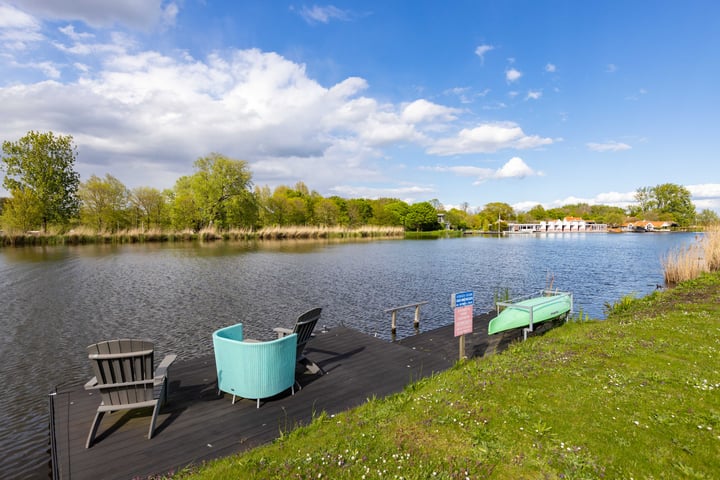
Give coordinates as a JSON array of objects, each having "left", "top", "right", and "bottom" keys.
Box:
[{"left": 0, "top": 233, "right": 695, "bottom": 478}]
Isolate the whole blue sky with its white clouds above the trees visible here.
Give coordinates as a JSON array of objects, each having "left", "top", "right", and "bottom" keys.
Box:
[{"left": 0, "top": 0, "right": 720, "bottom": 212}]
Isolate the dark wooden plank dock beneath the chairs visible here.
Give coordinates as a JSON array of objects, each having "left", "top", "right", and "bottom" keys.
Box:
[{"left": 50, "top": 313, "right": 556, "bottom": 479}]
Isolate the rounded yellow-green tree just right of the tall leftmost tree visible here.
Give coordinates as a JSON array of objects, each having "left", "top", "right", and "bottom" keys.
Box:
[{"left": 78, "top": 173, "right": 129, "bottom": 232}]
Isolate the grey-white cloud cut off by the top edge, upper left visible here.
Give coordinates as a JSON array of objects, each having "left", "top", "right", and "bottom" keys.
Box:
[{"left": 11, "top": 0, "right": 178, "bottom": 30}]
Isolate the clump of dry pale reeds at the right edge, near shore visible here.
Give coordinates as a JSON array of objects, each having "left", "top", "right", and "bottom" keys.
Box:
[{"left": 662, "top": 225, "right": 720, "bottom": 285}]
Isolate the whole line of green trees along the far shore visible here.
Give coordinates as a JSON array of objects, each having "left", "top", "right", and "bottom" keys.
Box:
[{"left": 0, "top": 131, "right": 718, "bottom": 233}]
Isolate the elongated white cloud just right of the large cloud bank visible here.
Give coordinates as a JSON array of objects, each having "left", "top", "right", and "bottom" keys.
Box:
[{"left": 427, "top": 122, "right": 553, "bottom": 155}]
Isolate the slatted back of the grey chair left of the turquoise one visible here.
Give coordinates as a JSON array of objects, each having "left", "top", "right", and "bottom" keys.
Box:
[{"left": 87, "top": 339, "right": 154, "bottom": 405}]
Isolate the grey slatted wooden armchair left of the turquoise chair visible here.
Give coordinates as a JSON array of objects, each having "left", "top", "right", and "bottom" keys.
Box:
[{"left": 85, "top": 339, "right": 176, "bottom": 448}]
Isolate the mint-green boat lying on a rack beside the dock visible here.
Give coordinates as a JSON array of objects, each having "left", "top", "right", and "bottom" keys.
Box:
[{"left": 488, "top": 290, "right": 572, "bottom": 335}]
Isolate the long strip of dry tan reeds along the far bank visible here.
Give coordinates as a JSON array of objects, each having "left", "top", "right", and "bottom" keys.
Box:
[{"left": 0, "top": 225, "right": 405, "bottom": 247}]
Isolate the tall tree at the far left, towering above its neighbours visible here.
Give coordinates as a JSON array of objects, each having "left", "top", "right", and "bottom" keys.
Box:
[{"left": 2, "top": 131, "right": 80, "bottom": 232}]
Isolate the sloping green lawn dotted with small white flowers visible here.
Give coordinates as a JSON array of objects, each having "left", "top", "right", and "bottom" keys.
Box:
[{"left": 170, "top": 274, "right": 720, "bottom": 480}]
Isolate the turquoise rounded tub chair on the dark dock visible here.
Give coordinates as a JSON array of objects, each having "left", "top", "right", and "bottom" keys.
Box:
[{"left": 213, "top": 323, "right": 297, "bottom": 408}]
